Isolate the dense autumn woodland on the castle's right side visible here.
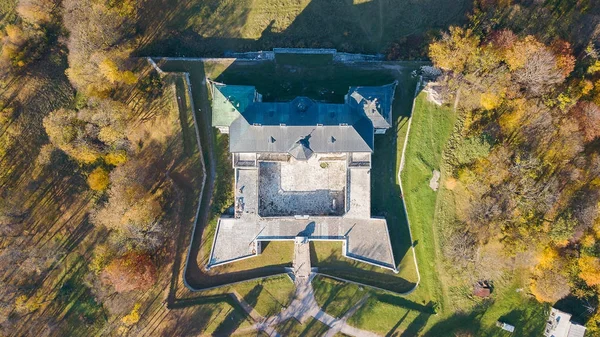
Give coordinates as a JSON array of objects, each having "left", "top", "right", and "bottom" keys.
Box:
[{"left": 429, "top": 0, "right": 600, "bottom": 329}]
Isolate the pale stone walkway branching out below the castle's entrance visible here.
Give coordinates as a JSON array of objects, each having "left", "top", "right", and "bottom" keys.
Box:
[{"left": 232, "top": 237, "right": 378, "bottom": 337}]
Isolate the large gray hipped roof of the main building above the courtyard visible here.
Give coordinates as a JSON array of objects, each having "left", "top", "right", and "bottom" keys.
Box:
[{"left": 229, "top": 97, "right": 374, "bottom": 153}]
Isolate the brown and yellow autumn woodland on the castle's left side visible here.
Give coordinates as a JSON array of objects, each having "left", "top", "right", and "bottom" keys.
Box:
[{"left": 0, "top": 0, "right": 174, "bottom": 334}]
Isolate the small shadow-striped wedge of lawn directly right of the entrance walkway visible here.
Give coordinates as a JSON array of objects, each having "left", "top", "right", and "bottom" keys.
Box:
[{"left": 312, "top": 276, "right": 369, "bottom": 318}]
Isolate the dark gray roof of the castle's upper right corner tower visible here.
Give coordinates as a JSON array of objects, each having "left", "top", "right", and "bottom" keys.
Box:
[{"left": 346, "top": 81, "right": 398, "bottom": 129}]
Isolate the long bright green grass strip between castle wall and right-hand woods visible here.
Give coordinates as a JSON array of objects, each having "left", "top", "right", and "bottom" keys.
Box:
[{"left": 350, "top": 94, "right": 456, "bottom": 336}]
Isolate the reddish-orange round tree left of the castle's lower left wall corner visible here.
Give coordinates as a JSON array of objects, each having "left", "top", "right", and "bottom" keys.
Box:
[{"left": 102, "top": 252, "right": 156, "bottom": 293}]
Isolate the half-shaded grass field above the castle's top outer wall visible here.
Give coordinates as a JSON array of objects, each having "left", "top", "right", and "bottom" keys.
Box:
[{"left": 139, "top": 0, "right": 470, "bottom": 57}]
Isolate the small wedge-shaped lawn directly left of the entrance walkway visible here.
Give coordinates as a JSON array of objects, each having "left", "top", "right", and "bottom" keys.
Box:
[{"left": 234, "top": 276, "right": 295, "bottom": 317}]
